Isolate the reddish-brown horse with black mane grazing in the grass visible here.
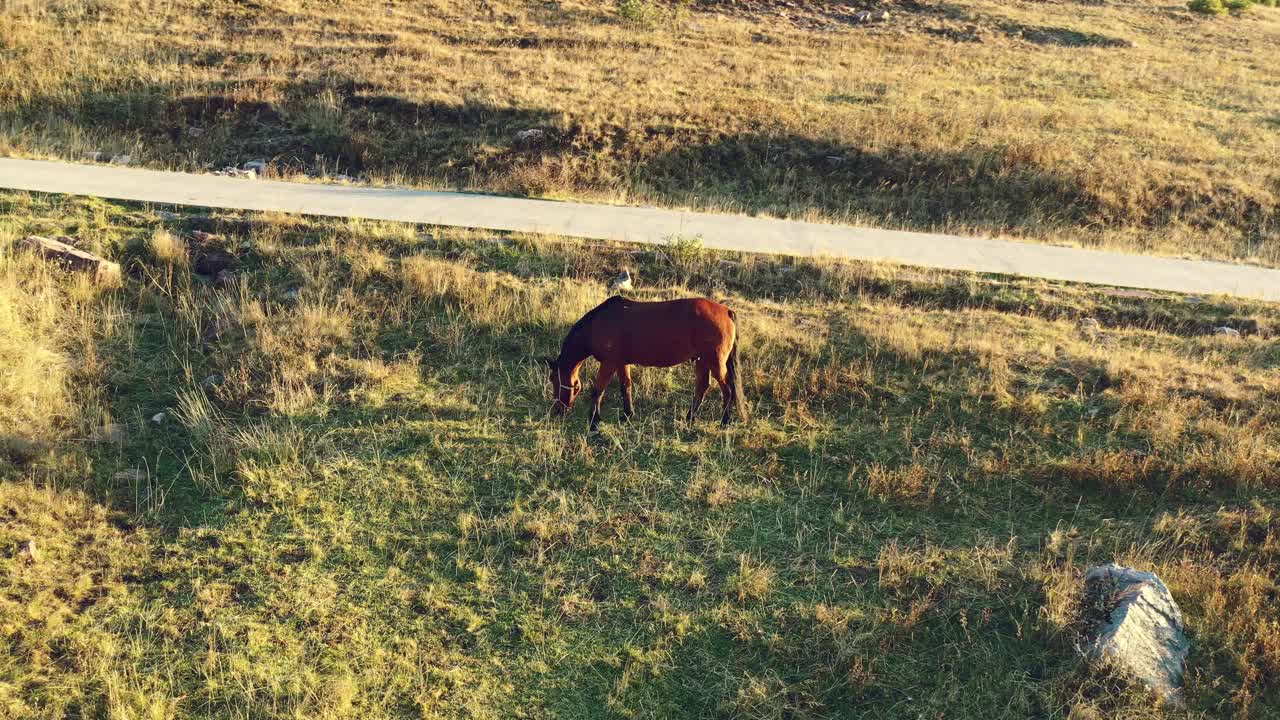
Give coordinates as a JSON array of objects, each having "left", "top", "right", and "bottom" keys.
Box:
[{"left": 545, "top": 296, "right": 746, "bottom": 430}]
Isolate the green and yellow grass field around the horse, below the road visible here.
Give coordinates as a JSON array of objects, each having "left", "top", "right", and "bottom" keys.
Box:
[{"left": 0, "top": 188, "right": 1280, "bottom": 720}]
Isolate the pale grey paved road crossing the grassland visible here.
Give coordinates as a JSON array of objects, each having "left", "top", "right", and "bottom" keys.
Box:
[{"left": 0, "top": 158, "right": 1280, "bottom": 301}]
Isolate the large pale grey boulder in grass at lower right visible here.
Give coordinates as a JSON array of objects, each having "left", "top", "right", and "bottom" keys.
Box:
[{"left": 1084, "top": 564, "right": 1192, "bottom": 705}]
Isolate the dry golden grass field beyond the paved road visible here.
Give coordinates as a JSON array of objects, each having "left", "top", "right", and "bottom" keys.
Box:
[{"left": 0, "top": 0, "right": 1280, "bottom": 265}]
